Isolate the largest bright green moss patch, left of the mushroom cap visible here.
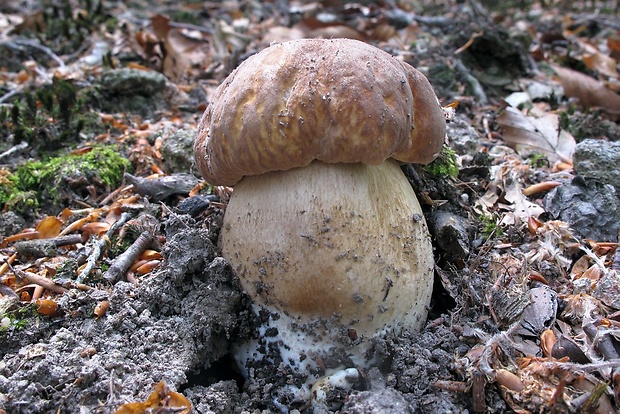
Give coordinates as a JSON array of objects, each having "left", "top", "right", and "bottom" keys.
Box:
[{"left": 0, "top": 146, "right": 130, "bottom": 212}]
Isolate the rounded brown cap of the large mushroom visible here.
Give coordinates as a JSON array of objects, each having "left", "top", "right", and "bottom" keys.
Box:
[{"left": 195, "top": 39, "right": 446, "bottom": 185}]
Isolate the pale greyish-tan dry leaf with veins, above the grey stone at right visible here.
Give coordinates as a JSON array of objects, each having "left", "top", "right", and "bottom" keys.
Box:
[{"left": 497, "top": 107, "right": 576, "bottom": 163}]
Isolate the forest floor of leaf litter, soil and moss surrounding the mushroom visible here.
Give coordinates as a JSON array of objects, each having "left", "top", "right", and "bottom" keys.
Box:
[{"left": 0, "top": 0, "right": 620, "bottom": 413}]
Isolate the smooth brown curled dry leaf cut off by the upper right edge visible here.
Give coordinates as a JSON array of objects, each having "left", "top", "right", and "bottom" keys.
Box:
[{"left": 552, "top": 65, "right": 620, "bottom": 120}]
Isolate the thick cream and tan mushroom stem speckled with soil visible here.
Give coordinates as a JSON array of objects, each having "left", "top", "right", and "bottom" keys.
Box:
[{"left": 220, "top": 159, "right": 433, "bottom": 372}]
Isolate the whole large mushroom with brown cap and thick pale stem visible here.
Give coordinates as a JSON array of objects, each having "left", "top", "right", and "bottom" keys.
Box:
[{"left": 194, "top": 39, "right": 446, "bottom": 394}]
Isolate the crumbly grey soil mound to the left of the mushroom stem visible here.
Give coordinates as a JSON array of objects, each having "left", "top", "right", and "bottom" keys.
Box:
[{"left": 0, "top": 215, "right": 242, "bottom": 413}]
